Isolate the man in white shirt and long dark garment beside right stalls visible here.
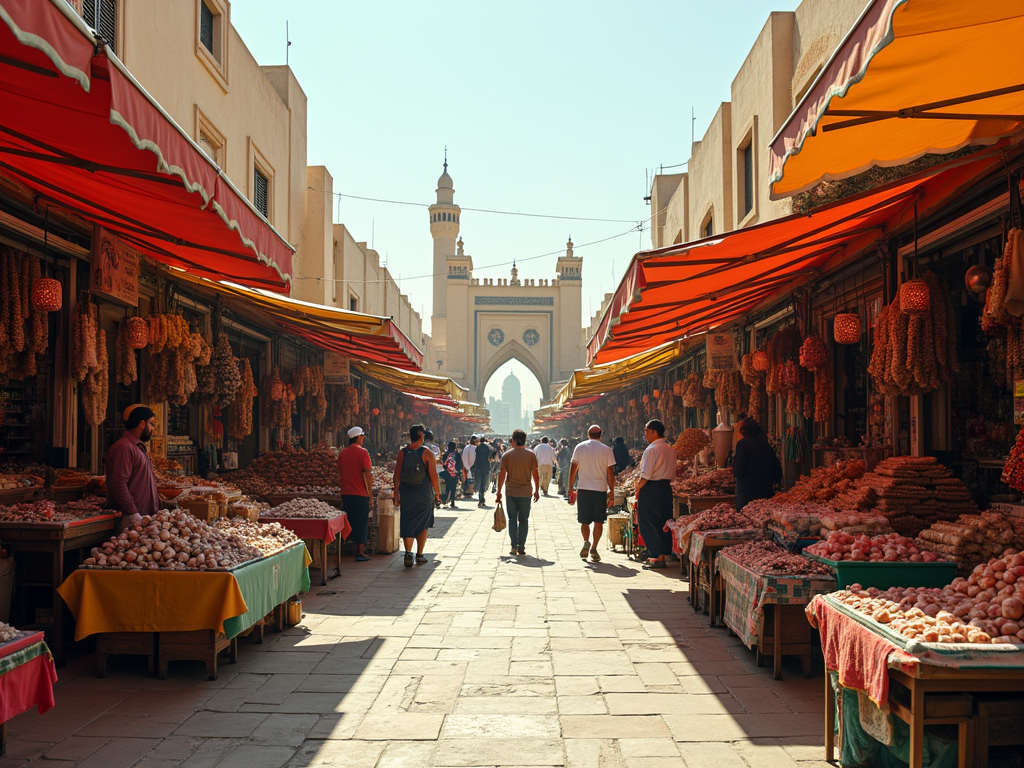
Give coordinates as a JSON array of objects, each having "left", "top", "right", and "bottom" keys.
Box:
[{"left": 637, "top": 419, "right": 676, "bottom": 569}]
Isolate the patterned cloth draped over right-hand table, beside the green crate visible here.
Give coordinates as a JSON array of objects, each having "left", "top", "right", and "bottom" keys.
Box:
[{"left": 716, "top": 550, "right": 836, "bottom": 648}]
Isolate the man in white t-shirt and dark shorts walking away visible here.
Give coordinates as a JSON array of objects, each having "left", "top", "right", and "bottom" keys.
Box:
[{"left": 569, "top": 424, "right": 615, "bottom": 562}]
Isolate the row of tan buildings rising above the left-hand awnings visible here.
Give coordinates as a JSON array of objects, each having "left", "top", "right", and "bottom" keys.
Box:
[{"left": 72, "top": 0, "right": 428, "bottom": 350}]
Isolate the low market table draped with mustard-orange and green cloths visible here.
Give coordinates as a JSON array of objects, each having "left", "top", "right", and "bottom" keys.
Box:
[{"left": 58, "top": 542, "right": 310, "bottom": 679}]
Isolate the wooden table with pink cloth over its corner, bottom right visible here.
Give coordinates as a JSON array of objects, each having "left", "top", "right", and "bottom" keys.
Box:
[{"left": 807, "top": 595, "right": 1024, "bottom": 768}]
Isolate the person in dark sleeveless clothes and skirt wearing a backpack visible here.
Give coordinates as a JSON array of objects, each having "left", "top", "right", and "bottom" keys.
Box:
[{"left": 394, "top": 424, "right": 441, "bottom": 568}]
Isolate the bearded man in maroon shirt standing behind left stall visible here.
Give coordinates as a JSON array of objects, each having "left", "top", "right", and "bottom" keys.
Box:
[{"left": 105, "top": 406, "right": 160, "bottom": 529}]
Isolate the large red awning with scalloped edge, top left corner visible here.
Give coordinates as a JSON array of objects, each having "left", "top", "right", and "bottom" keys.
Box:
[{"left": 0, "top": 0, "right": 294, "bottom": 293}]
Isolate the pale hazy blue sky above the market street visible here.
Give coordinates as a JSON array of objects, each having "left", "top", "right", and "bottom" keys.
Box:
[{"left": 231, "top": 0, "right": 797, "bottom": 415}]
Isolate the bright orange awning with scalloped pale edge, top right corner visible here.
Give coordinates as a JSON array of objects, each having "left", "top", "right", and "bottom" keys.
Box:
[{"left": 768, "top": 0, "right": 1024, "bottom": 199}]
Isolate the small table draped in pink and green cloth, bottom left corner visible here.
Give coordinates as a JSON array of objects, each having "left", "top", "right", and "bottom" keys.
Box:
[{"left": 0, "top": 632, "right": 57, "bottom": 758}]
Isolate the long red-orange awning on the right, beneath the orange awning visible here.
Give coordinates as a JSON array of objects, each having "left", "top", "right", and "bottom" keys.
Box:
[{"left": 587, "top": 151, "right": 1004, "bottom": 364}]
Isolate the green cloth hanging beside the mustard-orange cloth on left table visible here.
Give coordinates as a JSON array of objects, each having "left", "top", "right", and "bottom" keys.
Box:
[{"left": 224, "top": 542, "right": 309, "bottom": 639}]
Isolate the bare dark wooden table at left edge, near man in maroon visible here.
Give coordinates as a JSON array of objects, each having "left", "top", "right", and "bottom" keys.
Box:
[{"left": 0, "top": 513, "right": 121, "bottom": 667}]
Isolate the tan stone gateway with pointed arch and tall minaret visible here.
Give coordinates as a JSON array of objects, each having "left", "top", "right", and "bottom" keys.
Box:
[{"left": 424, "top": 162, "right": 586, "bottom": 402}]
